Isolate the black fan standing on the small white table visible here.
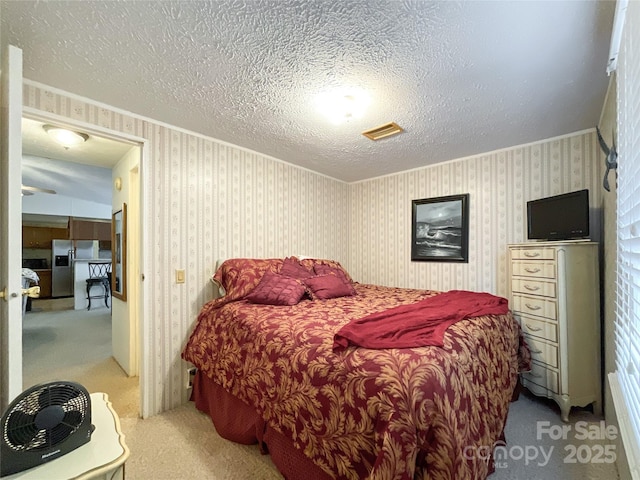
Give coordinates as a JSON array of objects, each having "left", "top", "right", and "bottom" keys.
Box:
[{"left": 0, "top": 381, "right": 94, "bottom": 477}]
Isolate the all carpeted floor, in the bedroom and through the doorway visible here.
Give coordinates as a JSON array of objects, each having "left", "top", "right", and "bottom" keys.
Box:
[{"left": 23, "top": 300, "right": 618, "bottom": 480}]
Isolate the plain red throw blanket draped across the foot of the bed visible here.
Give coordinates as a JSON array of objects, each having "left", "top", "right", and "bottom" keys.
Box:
[{"left": 333, "top": 290, "right": 509, "bottom": 352}]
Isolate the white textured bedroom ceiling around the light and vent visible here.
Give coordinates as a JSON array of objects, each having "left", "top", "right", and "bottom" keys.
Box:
[{"left": 0, "top": 0, "right": 615, "bottom": 181}]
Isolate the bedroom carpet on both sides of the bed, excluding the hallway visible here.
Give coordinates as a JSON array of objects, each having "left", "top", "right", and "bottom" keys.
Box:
[{"left": 121, "top": 393, "right": 618, "bottom": 480}]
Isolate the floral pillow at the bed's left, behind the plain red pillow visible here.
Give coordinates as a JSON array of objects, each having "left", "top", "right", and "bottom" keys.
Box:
[{"left": 213, "top": 258, "right": 282, "bottom": 299}]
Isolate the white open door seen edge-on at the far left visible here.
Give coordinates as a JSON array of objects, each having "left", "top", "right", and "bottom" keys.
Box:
[{"left": 0, "top": 44, "right": 22, "bottom": 410}]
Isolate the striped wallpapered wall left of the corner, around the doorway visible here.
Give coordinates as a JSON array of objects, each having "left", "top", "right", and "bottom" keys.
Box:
[{"left": 23, "top": 81, "right": 349, "bottom": 415}]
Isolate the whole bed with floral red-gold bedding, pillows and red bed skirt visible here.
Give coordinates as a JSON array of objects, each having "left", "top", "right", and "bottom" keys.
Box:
[{"left": 182, "top": 257, "right": 530, "bottom": 480}]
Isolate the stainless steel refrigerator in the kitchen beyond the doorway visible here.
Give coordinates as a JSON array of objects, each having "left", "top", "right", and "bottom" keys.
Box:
[{"left": 51, "top": 240, "right": 96, "bottom": 298}]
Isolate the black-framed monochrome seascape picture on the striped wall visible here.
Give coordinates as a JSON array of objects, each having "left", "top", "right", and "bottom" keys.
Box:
[{"left": 411, "top": 193, "right": 469, "bottom": 263}]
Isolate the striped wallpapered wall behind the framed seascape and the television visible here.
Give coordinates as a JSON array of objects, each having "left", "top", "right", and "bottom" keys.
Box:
[{"left": 349, "top": 130, "right": 601, "bottom": 295}]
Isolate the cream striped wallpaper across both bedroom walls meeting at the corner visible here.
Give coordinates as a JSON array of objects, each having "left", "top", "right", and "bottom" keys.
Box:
[{"left": 24, "top": 81, "right": 601, "bottom": 415}]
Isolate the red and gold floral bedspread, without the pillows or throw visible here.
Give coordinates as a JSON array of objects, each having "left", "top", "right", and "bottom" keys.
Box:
[{"left": 183, "top": 284, "right": 526, "bottom": 480}]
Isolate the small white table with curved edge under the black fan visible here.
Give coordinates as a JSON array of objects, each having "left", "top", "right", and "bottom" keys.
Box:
[{"left": 2, "top": 393, "right": 129, "bottom": 480}]
